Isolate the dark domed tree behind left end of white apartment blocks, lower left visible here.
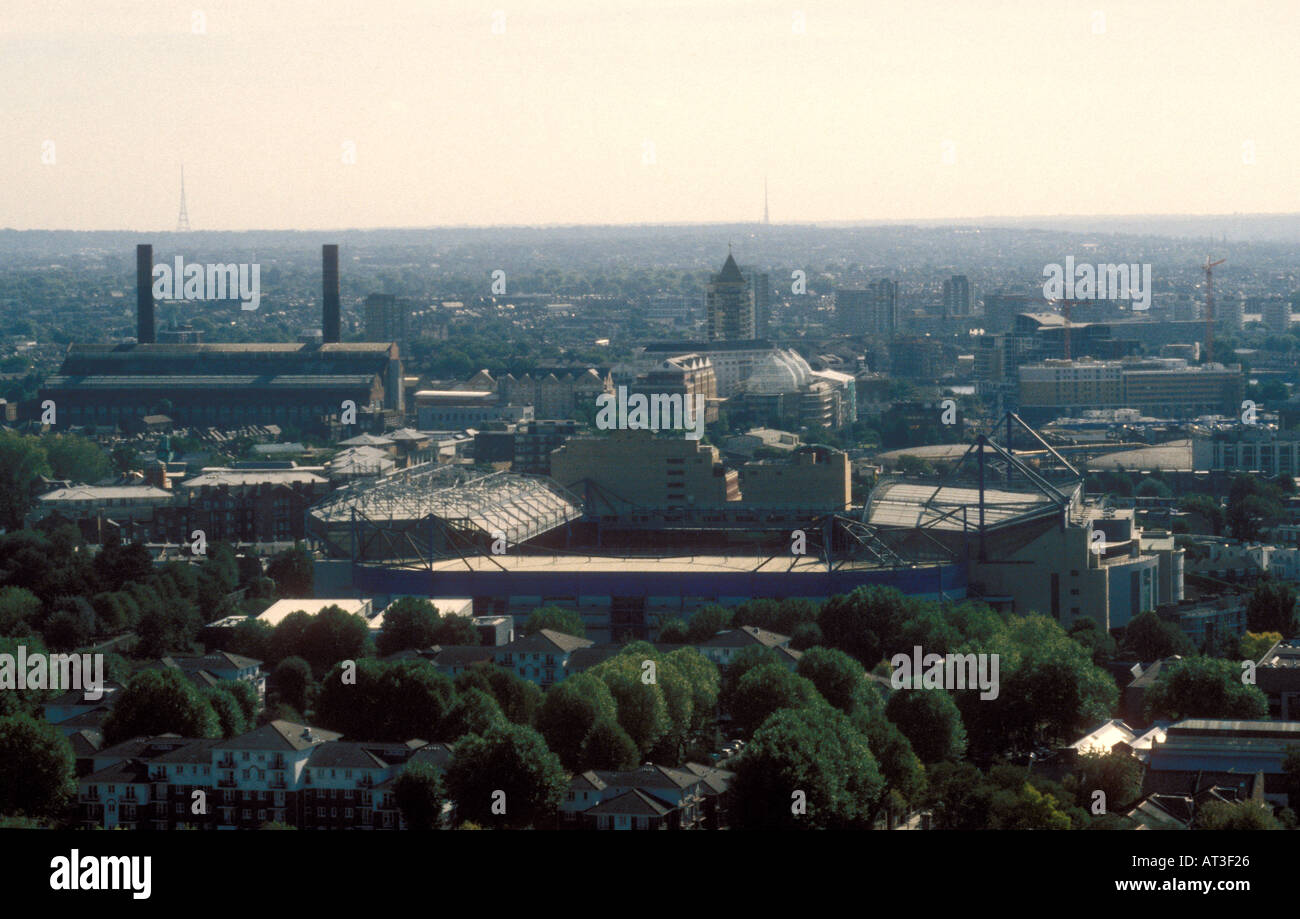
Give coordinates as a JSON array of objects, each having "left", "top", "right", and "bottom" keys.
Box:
[{"left": 104, "top": 669, "right": 221, "bottom": 746}]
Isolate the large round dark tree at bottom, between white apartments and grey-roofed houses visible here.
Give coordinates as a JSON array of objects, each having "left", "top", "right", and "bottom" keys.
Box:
[{"left": 446, "top": 724, "right": 568, "bottom": 828}]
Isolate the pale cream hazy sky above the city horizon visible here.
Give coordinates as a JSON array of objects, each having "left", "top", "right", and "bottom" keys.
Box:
[{"left": 0, "top": 0, "right": 1300, "bottom": 230}]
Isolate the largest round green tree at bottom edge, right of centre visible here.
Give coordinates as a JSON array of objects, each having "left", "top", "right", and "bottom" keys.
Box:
[{"left": 732, "top": 703, "right": 884, "bottom": 829}]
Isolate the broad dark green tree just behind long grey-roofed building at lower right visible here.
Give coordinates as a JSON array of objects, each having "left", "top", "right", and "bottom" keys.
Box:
[{"left": 1145, "top": 658, "right": 1269, "bottom": 721}]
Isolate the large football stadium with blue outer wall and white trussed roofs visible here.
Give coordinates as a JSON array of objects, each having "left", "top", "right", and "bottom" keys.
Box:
[{"left": 308, "top": 416, "right": 1107, "bottom": 638}]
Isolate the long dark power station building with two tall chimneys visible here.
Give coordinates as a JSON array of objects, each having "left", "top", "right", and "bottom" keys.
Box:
[{"left": 39, "top": 246, "right": 404, "bottom": 428}]
